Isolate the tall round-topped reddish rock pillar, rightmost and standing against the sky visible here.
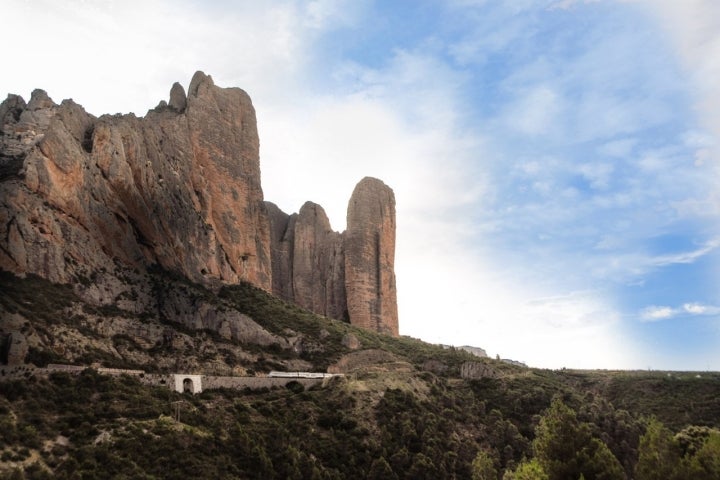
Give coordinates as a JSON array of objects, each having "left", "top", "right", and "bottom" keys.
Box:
[{"left": 345, "top": 177, "right": 398, "bottom": 336}]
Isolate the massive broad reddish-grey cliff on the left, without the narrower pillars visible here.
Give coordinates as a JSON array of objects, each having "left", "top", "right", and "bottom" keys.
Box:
[{"left": 0, "top": 72, "right": 272, "bottom": 290}]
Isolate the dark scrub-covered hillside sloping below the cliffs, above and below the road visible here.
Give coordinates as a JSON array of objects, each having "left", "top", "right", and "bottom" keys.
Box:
[{"left": 0, "top": 269, "right": 720, "bottom": 479}]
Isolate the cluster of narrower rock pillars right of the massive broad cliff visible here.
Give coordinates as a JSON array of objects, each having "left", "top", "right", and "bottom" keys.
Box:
[{"left": 267, "top": 178, "right": 398, "bottom": 336}]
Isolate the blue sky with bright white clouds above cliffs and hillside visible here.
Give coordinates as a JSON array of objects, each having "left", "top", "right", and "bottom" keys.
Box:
[{"left": 0, "top": 0, "right": 720, "bottom": 371}]
